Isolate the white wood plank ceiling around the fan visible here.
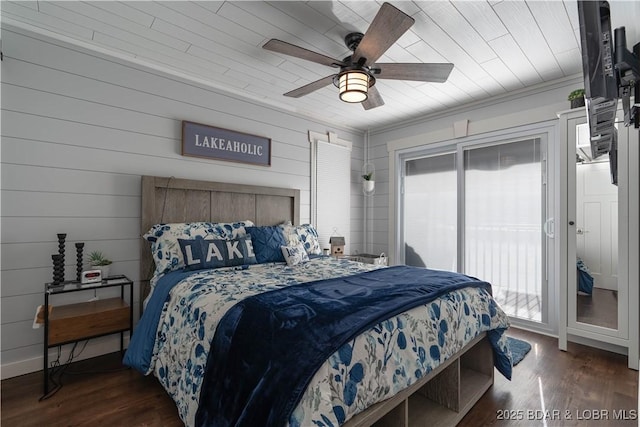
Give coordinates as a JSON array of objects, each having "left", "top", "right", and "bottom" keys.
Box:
[{"left": 1, "top": 0, "right": 640, "bottom": 129}]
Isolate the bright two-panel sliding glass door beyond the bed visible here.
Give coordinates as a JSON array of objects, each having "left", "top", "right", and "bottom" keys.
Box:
[{"left": 400, "top": 137, "right": 547, "bottom": 322}]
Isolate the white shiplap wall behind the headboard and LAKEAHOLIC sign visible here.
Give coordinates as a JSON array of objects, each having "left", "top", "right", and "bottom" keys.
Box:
[{"left": 0, "top": 27, "right": 363, "bottom": 378}]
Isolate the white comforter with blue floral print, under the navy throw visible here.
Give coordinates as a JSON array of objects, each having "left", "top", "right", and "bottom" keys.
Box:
[{"left": 139, "top": 257, "right": 509, "bottom": 427}]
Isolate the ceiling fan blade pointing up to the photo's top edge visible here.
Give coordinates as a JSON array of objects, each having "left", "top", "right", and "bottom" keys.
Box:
[{"left": 353, "top": 3, "right": 415, "bottom": 65}]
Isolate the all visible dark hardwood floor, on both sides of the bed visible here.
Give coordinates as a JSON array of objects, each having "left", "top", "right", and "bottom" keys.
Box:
[{"left": 0, "top": 328, "right": 638, "bottom": 427}]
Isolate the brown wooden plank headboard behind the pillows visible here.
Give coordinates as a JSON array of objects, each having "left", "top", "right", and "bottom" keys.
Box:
[{"left": 140, "top": 176, "right": 300, "bottom": 310}]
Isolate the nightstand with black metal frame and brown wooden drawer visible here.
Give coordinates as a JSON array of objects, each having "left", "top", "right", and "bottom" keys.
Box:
[{"left": 43, "top": 276, "right": 133, "bottom": 395}]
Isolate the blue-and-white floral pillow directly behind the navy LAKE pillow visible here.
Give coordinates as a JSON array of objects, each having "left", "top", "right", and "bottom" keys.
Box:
[{"left": 142, "top": 220, "right": 253, "bottom": 275}]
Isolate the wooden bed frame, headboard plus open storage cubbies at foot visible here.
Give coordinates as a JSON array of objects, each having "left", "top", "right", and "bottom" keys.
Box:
[{"left": 140, "top": 176, "right": 494, "bottom": 427}]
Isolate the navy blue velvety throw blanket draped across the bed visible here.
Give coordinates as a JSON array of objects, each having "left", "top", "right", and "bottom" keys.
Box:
[{"left": 196, "top": 266, "right": 492, "bottom": 427}]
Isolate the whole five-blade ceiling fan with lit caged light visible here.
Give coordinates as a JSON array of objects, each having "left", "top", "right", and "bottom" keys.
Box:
[{"left": 262, "top": 3, "right": 453, "bottom": 110}]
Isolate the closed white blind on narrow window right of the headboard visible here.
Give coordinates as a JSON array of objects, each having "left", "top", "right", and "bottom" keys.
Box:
[{"left": 312, "top": 141, "right": 351, "bottom": 254}]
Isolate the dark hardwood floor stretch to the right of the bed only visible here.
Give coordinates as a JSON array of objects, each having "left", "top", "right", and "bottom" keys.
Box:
[{"left": 458, "top": 328, "right": 638, "bottom": 427}]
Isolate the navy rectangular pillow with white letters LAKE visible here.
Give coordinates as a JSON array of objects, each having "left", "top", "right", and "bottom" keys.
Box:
[{"left": 178, "top": 234, "right": 256, "bottom": 270}]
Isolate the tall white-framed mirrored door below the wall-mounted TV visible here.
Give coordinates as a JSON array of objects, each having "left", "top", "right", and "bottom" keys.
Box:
[{"left": 560, "top": 108, "right": 639, "bottom": 369}]
